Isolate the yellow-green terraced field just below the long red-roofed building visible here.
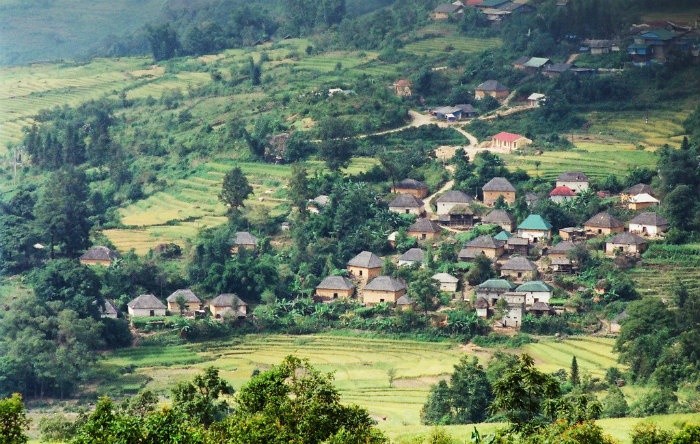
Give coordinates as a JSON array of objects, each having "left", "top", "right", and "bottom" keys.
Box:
[{"left": 502, "top": 140, "right": 657, "bottom": 180}]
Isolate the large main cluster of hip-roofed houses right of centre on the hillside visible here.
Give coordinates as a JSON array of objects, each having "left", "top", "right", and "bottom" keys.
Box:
[{"left": 315, "top": 172, "right": 668, "bottom": 328}]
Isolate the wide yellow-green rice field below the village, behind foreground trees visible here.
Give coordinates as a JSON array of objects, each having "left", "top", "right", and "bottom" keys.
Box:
[{"left": 94, "top": 333, "right": 614, "bottom": 432}]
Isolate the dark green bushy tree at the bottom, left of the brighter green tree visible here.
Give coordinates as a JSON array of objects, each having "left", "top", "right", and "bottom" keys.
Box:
[{"left": 421, "top": 356, "right": 493, "bottom": 424}]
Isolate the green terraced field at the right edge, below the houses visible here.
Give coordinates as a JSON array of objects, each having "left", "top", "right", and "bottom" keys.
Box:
[{"left": 630, "top": 244, "right": 700, "bottom": 299}]
